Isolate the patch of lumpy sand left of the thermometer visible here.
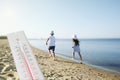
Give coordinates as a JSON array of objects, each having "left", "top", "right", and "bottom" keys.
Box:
[{"left": 0, "top": 39, "right": 18, "bottom": 80}]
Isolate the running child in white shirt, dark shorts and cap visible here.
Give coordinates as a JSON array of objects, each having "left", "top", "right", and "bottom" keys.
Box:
[{"left": 46, "top": 31, "right": 55, "bottom": 60}]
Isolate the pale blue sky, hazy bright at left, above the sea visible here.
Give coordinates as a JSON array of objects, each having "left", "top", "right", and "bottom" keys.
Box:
[{"left": 0, "top": 0, "right": 120, "bottom": 38}]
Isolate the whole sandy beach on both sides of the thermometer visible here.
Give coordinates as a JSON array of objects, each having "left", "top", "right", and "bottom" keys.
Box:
[{"left": 0, "top": 39, "right": 120, "bottom": 80}]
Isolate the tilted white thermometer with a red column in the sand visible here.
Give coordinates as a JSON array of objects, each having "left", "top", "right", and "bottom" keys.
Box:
[{"left": 7, "top": 31, "right": 44, "bottom": 80}]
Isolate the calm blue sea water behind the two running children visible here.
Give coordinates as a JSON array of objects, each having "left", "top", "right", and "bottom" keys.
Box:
[{"left": 29, "top": 39, "right": 120, "bottom": 72}]
